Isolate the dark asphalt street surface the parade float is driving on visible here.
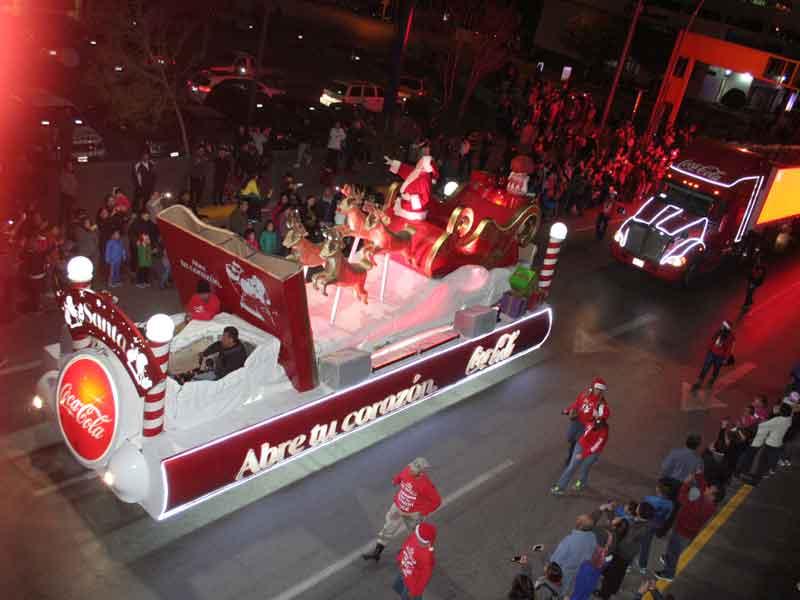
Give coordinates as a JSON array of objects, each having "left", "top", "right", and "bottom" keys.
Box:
[{"left": 0, "top": 203, "right": 800, "bottom": 600}]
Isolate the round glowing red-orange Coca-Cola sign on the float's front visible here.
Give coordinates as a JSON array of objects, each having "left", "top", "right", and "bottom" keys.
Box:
[{"left": 58, "top": 356, "right": 117, "bottom": 462}]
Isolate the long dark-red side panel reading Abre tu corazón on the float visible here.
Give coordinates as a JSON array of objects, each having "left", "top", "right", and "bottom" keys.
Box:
[{"left": 159, "top": 307, "right": 552, "bottom": 519}]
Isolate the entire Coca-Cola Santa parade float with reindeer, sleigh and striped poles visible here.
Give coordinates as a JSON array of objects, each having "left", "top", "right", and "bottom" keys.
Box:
[{"left": 32, "top": 159, "right": 566, "bottom": 519}]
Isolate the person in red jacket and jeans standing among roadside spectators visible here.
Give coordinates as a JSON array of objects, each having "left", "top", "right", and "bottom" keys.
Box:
[{"left": 656, "top": 471, "right": 718, "bottom": 581}]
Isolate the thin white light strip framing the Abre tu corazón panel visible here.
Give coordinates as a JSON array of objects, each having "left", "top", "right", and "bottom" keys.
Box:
[{"left": 157, "top": 306, "right": 553, "bottom": 521}]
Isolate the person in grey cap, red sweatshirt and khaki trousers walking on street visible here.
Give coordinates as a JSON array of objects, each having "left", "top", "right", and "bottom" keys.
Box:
[{"left": 361, "top": 457, "right": 442, "bottom": 562}]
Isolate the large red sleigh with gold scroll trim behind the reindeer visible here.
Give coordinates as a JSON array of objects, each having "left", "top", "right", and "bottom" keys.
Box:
[{"left": 385, "top": 172, "right": 541, "bottom": 278}]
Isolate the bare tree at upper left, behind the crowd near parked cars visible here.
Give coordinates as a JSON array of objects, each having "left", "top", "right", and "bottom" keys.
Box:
[{"left": 89, "top": 0, "right": 208, "bottom": 156}]
